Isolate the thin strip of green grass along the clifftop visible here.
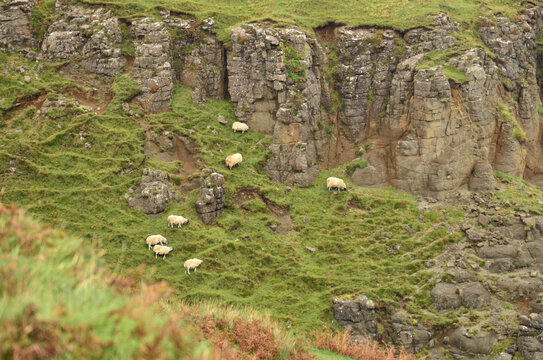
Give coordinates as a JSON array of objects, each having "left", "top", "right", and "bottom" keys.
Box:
[{"left": 68, "top": 0, "right": 520, "bottom": 41}]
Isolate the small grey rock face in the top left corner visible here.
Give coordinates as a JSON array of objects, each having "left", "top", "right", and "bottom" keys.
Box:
[{"left": 0, "top": 0, "right": 36, "bottom": 50}]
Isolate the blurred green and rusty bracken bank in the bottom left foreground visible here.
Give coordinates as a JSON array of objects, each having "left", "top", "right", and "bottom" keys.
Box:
[{"left": 0, "top": 204, "right": 309, "bottom": 359}]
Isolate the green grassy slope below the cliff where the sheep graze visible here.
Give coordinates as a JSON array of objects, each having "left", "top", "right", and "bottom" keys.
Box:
[{"left": 0, "top": 52, "right": 468, "bottom": 333}]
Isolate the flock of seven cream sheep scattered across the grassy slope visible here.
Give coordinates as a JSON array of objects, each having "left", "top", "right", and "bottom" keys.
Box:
[{"left": 145, "top": 121, "right": 347, "bottom": 275}]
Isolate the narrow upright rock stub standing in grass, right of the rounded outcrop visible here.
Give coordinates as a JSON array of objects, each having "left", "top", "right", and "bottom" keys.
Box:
[{"left": 195, "top": 169, "right": 226, "bottom": 225}]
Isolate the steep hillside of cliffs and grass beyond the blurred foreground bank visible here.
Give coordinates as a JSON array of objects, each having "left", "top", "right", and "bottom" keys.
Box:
[{"left": 0, "top": 0, "right": 543, "bottom": 360}]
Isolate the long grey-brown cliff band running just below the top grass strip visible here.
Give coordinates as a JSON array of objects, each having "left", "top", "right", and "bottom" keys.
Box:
[{"left": 0, "top": 1, "right": 543, "bottom": 198}]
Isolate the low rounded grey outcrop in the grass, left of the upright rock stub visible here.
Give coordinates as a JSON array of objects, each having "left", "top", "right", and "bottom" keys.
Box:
[{"left": 124, "top": 169, "right": 179, "bottom": 215}]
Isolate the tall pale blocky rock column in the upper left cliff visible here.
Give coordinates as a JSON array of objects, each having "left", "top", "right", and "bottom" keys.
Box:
[{"left": 131, "top": 18, "right": 174, "bottom": 113}]
